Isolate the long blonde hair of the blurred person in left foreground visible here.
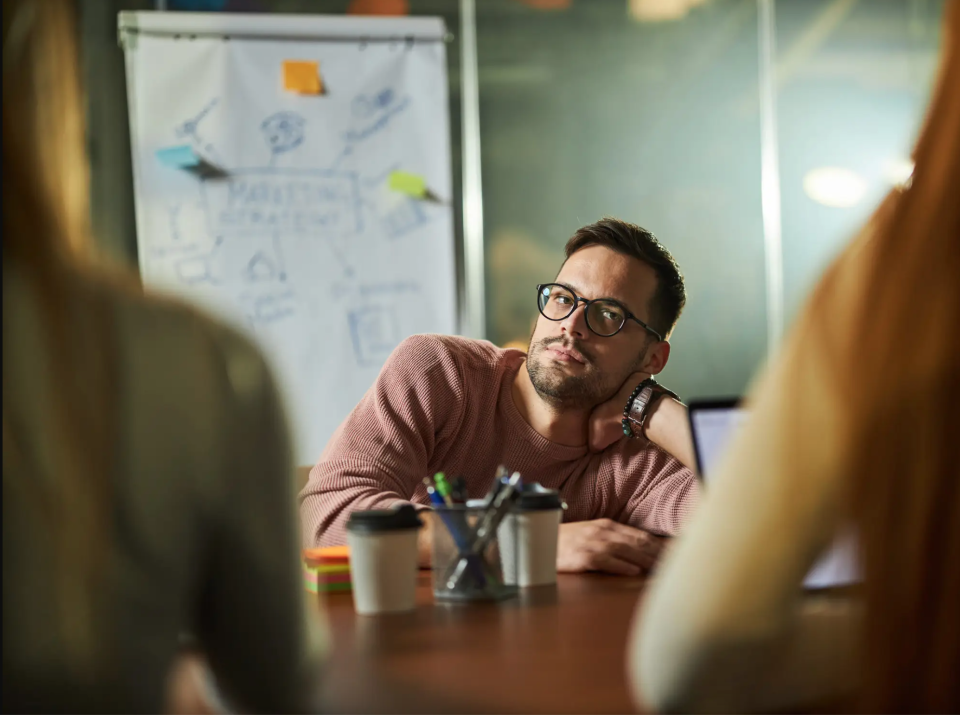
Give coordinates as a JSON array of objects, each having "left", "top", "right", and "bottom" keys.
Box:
[{"left": 3, "top": 0, "right": 115, "bottom": 666}]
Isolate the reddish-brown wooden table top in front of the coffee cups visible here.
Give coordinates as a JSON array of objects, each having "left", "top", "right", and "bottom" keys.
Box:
[{"left": 323, "top": 571, "right": 644, "bottom": 713}]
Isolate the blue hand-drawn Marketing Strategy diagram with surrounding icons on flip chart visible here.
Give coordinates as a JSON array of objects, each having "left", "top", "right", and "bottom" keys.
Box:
[{"left": 148, "top": 87, "right": 448, "bottom": 366}]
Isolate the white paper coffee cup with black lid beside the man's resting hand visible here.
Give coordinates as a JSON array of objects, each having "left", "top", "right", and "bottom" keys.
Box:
[{"left": 497, "top": 485, "right": 563, "bottom": 588}]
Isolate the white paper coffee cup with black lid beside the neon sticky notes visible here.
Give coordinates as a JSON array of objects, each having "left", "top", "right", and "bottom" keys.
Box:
[{"left": 347, "top": 505, "right": 422, "bottom": 615}]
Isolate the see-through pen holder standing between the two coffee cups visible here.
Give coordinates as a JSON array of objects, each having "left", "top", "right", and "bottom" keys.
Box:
[{"left": 432, "top": 504, "right": 517, "bottom": 601}]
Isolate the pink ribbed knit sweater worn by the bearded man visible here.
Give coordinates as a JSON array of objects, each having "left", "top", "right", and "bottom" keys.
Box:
[{"left": 300, "top": 335, "right": 698, "bottom": 547}]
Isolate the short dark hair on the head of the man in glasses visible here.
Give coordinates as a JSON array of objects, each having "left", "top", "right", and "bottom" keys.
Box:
[{"left": 564, "top": 217, "right": 687, "bottom": 338}]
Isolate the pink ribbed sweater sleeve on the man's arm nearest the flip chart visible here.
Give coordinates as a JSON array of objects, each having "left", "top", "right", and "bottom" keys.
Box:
[{"left": 300, "top": 335, "right": 463, "bottom": 547}]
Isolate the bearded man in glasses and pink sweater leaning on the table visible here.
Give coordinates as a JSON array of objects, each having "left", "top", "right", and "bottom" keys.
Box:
[{"left": 300, "top": 218, "right": 697, "bottom": 575}]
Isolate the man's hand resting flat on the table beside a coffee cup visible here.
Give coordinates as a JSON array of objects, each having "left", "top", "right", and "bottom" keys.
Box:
[{"left": 557, "top": 519, "right": 668, "bottom": 576}]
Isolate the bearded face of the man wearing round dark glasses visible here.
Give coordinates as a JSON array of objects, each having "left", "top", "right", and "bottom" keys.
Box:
[{"left": 527, "top": 246, "right": 666, "bottom": 409}]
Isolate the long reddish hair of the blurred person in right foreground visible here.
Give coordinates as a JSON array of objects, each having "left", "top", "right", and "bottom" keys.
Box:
[{"left": 798, "top": 2, "right": 960, "bottom": 712}]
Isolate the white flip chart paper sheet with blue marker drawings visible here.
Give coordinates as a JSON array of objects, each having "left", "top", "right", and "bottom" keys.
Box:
[{"left": 124, "top": 21, "right": 459, "bottom": 463}]
